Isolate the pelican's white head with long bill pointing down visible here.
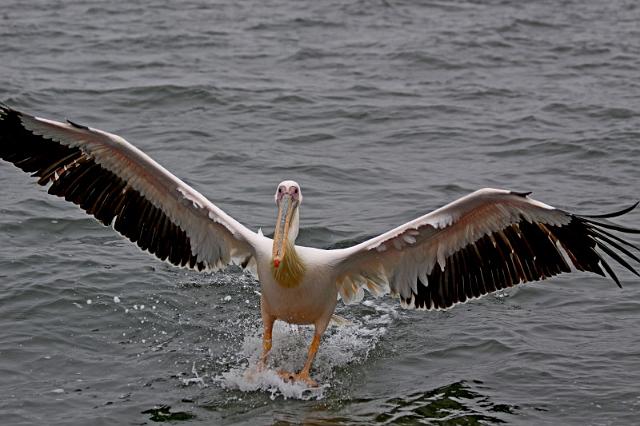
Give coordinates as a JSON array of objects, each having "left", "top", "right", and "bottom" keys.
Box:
[{"left": 273, "top": 180, "right": 302, "bottom": 268}]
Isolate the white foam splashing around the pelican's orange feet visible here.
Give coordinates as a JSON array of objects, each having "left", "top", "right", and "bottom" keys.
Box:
[{"left": 213, "top": 302, "right": 397, "bottom": 400}]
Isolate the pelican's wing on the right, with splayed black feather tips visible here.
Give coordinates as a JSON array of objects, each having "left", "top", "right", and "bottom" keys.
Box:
[{"left": 332, "top": 189, "right": 640, "bottom": 309}]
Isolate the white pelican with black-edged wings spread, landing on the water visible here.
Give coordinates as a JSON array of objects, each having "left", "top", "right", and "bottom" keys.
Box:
[{"left": 0, "top": 104, "right": 640, "bottom": 386}]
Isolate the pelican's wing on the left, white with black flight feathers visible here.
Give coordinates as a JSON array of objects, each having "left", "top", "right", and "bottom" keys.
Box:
[{"left": 0, "top": 104, "right": 263, "bottom": 270}]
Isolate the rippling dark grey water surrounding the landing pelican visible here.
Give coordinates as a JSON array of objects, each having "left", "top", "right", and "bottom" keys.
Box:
[{"left": 0, "top": 0, "right": 640, "bottom": 425}]
